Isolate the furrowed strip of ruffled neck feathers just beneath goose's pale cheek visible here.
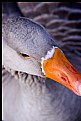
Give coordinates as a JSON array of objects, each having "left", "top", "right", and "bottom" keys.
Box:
[{"left": 2, "top": 65, "right": 46, "bottom": 84}]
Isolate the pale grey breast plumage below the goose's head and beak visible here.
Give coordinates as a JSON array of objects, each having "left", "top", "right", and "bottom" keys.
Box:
[{"left": 3, "top": 67, "right": 81, "bottom": 121}]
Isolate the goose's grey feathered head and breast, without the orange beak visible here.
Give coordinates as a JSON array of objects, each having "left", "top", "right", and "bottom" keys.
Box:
[{"left": 3, "top": 2, "right": 81, "bottom": 121}]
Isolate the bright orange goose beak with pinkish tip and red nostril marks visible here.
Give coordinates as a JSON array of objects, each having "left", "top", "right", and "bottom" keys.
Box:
[{"left": 42, "top": 48, "right": 81, "bottom": 96}]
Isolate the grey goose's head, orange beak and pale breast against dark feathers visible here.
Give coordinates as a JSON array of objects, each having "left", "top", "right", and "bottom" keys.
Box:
[{"left": 2, "top": 3, "right": 81, "bottom": 121}]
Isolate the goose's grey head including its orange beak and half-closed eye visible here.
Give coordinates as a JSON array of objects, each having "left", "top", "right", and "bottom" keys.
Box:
[{"left": 2, "top": 17, "right": 81, "bottom": 96}]
